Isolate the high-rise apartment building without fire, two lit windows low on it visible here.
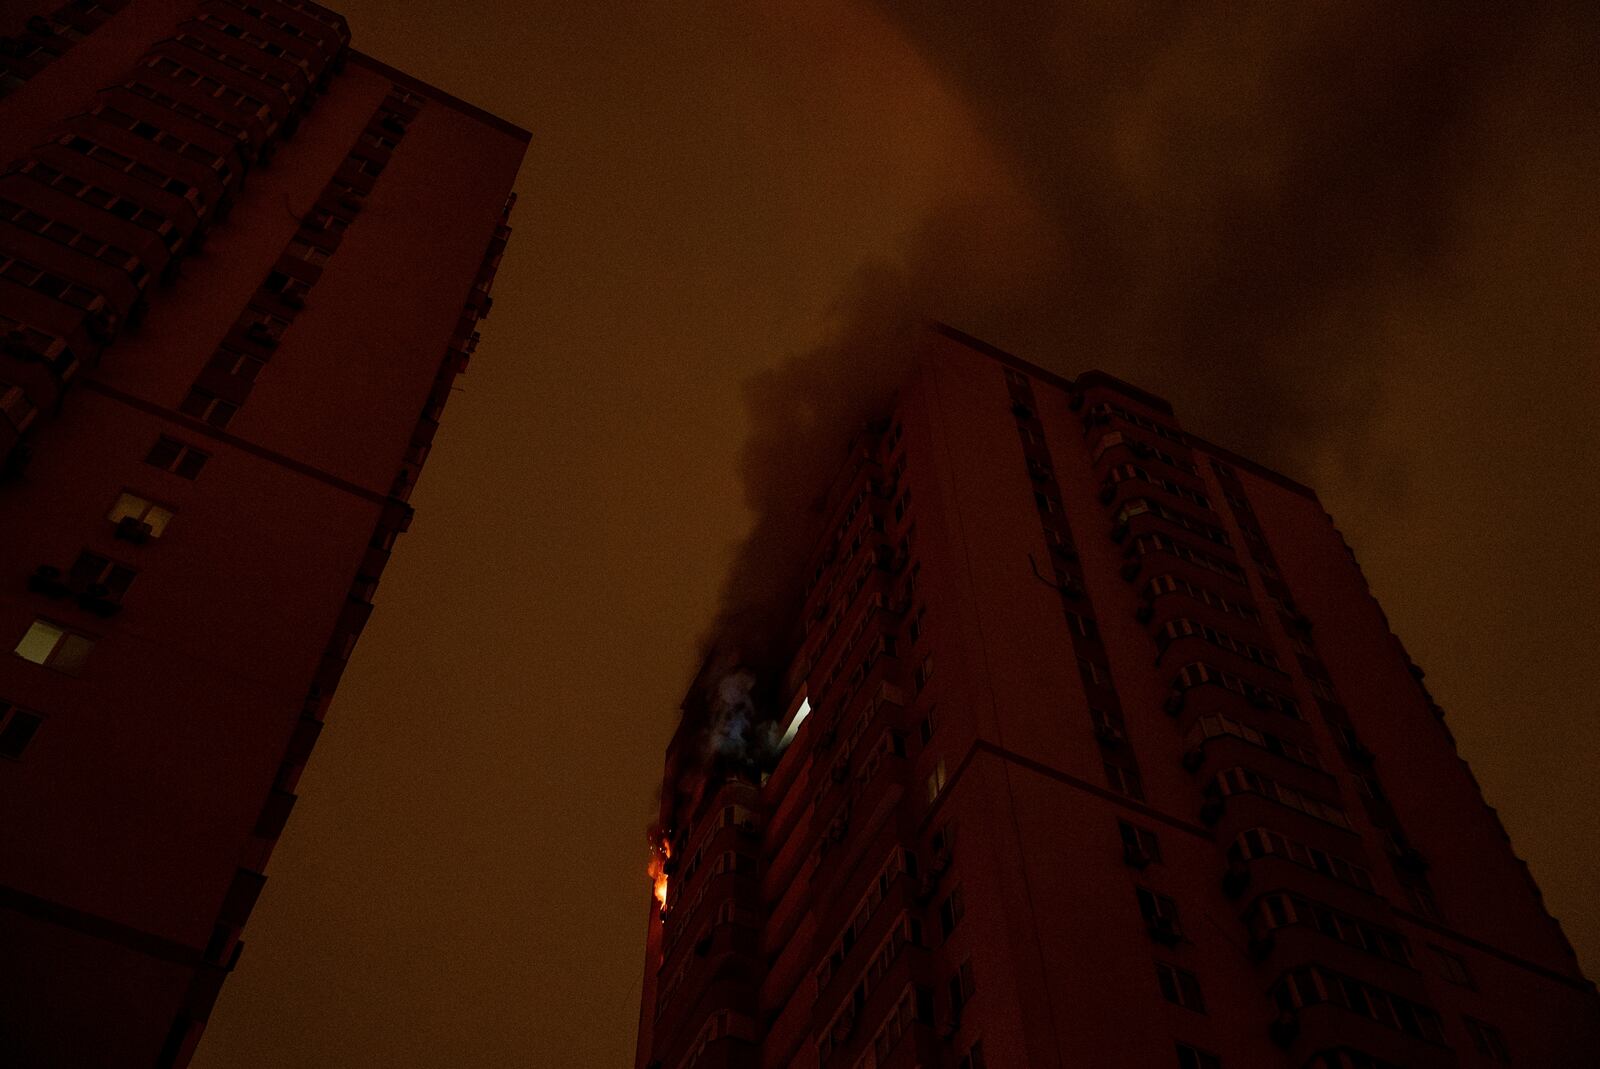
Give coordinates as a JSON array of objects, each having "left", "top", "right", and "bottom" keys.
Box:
[{"left": 0, "top": 0, "right": 528, "bottom": 1069}]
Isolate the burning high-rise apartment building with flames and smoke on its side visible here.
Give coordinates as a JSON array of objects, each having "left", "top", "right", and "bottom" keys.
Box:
[{"left": 635, "top": 330, "right": 1600, "bottom": 1069}]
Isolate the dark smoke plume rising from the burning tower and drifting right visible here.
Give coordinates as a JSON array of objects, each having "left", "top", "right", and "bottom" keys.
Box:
[{"left": 717, "top": 0, "right": 1600, "bottom": 650}]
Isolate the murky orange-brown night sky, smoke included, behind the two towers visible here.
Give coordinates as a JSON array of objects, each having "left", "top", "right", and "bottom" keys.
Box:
[{"left": 195, "top": 0, "right": 1600, "bottom": 1069}]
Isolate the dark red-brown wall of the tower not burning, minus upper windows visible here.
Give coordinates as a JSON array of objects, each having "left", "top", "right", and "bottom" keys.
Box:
[{"left": 0, "top": 0, "right": 528, "bottom": 1067}]
